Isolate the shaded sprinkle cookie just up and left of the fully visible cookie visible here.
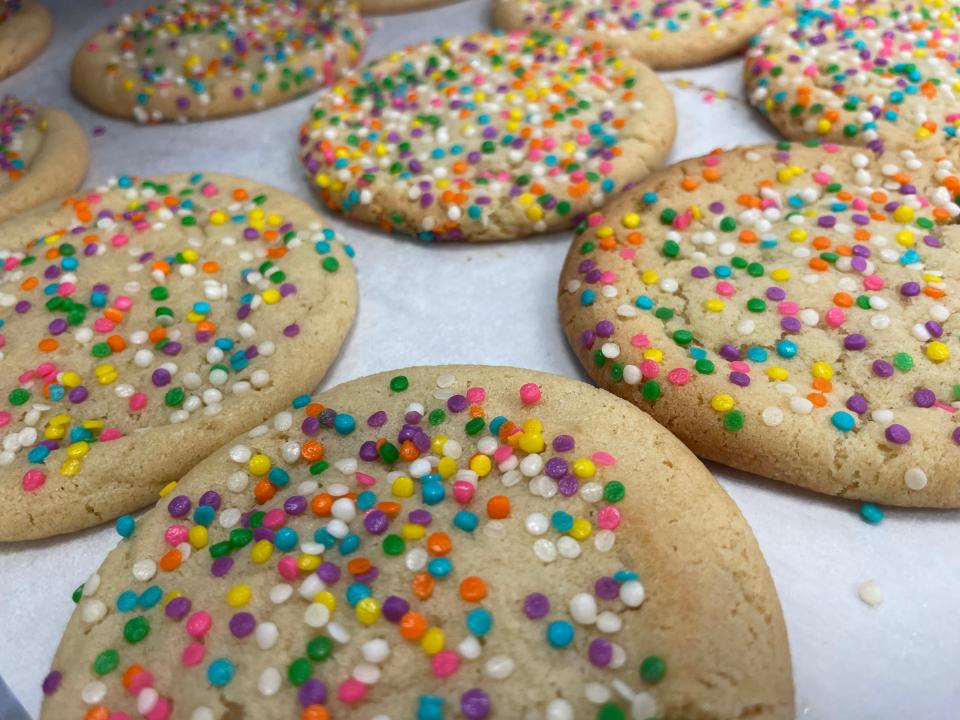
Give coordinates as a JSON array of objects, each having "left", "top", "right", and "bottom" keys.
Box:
[{"left": 71, "top": 0, "right": 367, "bottom": 123}]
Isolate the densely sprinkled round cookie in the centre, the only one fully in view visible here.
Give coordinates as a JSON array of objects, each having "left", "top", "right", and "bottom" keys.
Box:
[{"left": 300, "top": 33, "right": 676, "bottom": 241}]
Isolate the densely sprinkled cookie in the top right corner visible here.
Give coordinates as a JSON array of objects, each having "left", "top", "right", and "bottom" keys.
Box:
[{"left": 744, "top": 2, "right": 960, "bottom": 152}]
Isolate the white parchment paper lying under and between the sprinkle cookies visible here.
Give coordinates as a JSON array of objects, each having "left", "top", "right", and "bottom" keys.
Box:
[{"left": 0, "top": 0, "right": 960, "bottom": 720}]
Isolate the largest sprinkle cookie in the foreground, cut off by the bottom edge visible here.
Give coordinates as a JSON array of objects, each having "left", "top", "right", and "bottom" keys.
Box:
[{"left": 41, "top": 366, "right": 793, "bottom": 720}]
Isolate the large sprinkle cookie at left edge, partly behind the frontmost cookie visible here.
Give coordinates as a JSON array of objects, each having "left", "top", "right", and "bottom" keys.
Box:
[{"left": 0, "top": 173, "right": 356, "bottom": 540}]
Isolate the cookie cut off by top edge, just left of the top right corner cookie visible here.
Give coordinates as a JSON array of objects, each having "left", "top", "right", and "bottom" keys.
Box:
[{"left": 493, "top": 0, "right": 784, "bottom": 69}]
